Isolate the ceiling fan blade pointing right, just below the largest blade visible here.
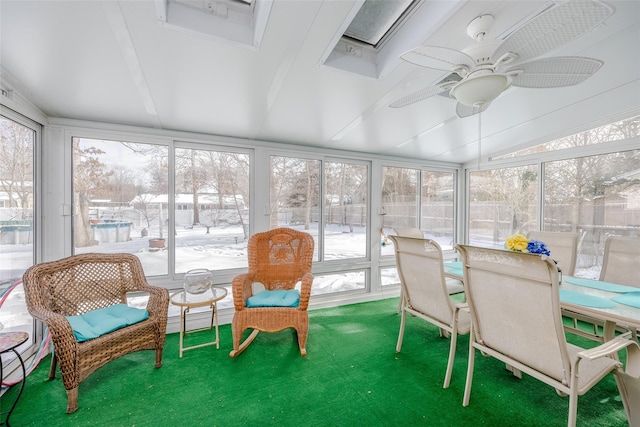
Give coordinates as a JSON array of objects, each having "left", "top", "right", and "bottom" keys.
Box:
[{"left": 505, "top": 56, "right": 603, "bottom": 88}]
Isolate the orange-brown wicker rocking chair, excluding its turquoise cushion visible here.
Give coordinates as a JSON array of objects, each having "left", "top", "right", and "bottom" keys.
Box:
[{"left": 229, "top": 228, "right": 314, "bottom": 357}]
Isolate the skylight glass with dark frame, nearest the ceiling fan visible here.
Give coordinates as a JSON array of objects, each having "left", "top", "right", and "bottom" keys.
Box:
[{"left": 344, "top": 0, "right": 417, "bottom": 47}]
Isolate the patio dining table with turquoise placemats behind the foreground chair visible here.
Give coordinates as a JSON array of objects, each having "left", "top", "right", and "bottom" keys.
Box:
[{"left": 444, "top": 261, "right": 640, "bottom": 341}]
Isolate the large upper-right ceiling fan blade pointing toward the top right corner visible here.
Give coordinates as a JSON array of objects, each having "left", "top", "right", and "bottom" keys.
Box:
[{"left": 492, "top": 0, "right": 613, "bottom": 63}]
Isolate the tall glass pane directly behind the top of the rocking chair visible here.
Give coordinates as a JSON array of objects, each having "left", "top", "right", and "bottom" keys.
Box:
[{"left": 270, "top": 156, "right": 320, "bottom": 259}]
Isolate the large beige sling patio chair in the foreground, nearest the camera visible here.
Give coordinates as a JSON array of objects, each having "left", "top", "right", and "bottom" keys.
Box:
[{"left": 457, "top": 245, "right": 640, "bottom": 426}]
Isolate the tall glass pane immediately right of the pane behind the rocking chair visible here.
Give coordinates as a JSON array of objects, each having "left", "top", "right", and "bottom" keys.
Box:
[{"left": 324, "top": 162, "right": 368, "bottom": 260}]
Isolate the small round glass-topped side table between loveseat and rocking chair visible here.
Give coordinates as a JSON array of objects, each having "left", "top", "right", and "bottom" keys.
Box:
[{"left": 171, "top": 286, "right": 227, "bottom": 357}]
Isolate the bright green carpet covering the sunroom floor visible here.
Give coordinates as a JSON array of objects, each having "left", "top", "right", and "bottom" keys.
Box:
[{"left": 2, "top": 298, "right": 627, "bottom": 427}]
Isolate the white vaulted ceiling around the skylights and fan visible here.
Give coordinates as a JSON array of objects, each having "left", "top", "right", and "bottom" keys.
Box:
[{"left": 0, "top": 0, "right": 640, "bottom": 163}]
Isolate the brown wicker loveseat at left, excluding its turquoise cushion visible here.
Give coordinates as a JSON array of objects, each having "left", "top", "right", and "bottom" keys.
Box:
[{"left": 23, "top": 254, "right": 169, "bottom": 413}]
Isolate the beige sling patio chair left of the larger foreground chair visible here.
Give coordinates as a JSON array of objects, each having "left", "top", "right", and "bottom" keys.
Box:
[{"left": 389, "top": 236, "right": 470, "bottom": 388}]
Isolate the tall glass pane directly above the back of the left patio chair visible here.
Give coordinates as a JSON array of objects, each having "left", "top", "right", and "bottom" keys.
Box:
[{"left": 420, "top": 171, "right": 455, "bottom": 249}]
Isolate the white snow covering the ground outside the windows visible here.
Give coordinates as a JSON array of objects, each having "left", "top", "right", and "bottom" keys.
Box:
[{"left": 0, "top": 223, "right": 600, "bottom": 336}]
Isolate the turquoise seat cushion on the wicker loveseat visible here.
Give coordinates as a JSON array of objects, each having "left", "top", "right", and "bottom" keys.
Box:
[{"left": 67, "top": 304, "right": 149, "bottom": 342}]
